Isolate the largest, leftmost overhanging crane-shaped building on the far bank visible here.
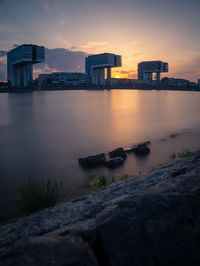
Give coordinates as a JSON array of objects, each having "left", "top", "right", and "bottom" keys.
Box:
[{"left": 7, "top": 44, "right": 44, "bottom": 87}]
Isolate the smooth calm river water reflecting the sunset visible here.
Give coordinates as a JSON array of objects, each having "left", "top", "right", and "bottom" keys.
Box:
[{"left": 0, "top": 90, "right": 200, "bottom": 220}]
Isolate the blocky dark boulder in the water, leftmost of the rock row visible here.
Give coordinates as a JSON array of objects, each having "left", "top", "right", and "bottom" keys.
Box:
[{"left": 79, "top": 153, "right": 106, "bottom": 168}]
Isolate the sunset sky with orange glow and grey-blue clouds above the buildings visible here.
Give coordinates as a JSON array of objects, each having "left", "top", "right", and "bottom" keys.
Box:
[{"left": 0, "top": 0, "right": 200, "bottom": 81}]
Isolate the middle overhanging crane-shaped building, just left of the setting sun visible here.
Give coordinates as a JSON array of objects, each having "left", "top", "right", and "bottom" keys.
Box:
[{"left": 85, "top": 53, "right": 122, "bottom": 85}]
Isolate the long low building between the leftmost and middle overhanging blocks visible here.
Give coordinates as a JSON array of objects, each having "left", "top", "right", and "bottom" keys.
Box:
[{"left": 52, "top": 72, "right": 92, "bottom": 85}]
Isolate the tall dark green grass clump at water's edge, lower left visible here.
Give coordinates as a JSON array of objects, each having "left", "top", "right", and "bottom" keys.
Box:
[{"left": 19, "top": 178, "right": 59, "bottom": 214}]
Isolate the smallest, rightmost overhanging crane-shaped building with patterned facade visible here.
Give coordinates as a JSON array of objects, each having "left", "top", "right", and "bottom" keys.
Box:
[{"left": 138, "top": 61, "right": 168, "bottom": 82}]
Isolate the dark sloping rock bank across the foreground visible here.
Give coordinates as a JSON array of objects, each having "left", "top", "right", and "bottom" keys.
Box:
[{"left": 0, "top": 153, "right": 200, "bottom": 266}]
